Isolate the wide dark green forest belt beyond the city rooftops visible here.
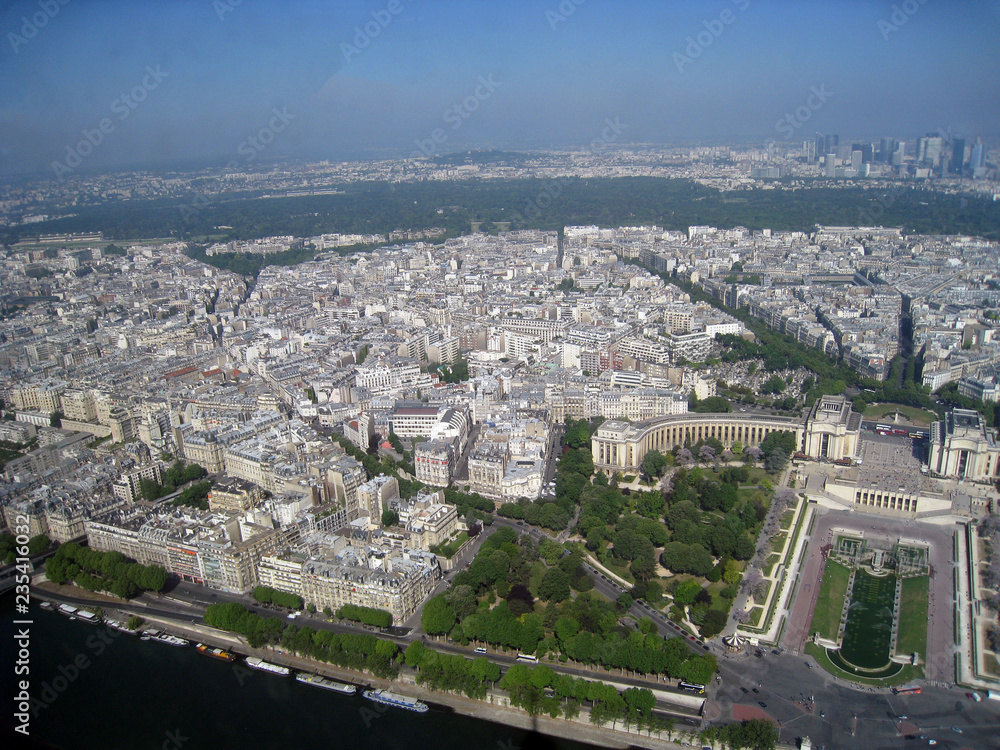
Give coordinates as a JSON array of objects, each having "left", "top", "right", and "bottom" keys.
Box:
[{"left": 7, "top": 177, "right": 1000, "bottom": 244}]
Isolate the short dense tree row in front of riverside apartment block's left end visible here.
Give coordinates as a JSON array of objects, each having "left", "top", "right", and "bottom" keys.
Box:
[{"left": 45, "top": 542, "right": 167, "bottom": 599}]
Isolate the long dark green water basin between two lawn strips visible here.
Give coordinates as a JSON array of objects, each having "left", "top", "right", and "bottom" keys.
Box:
[{"left": 840, "top": 570, "right": 896, "bottom": 669}]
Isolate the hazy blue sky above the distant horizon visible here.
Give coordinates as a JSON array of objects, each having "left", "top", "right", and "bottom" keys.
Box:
[{"left": 0, "top": 0, "right": 1000, "bottom": 176}]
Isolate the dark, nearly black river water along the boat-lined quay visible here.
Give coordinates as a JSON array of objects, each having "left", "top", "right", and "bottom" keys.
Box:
[{"left": 0, "top": 594, "right": 592, "bottom": 750}]
